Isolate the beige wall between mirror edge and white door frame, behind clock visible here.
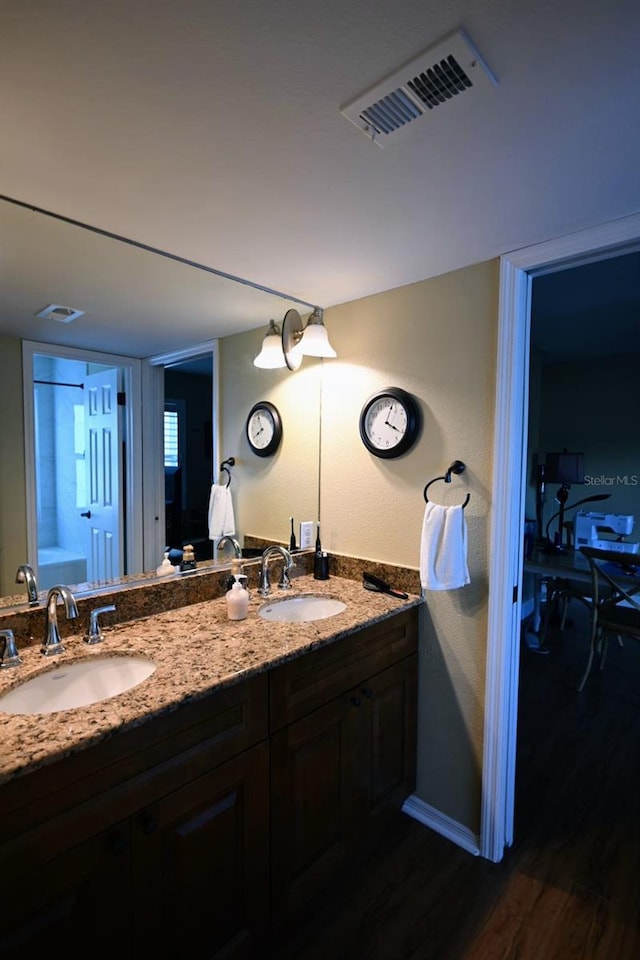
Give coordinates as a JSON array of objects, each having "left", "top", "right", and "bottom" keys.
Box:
[{"left": 321, "top": 260, "right": 499, "bottom": 832}]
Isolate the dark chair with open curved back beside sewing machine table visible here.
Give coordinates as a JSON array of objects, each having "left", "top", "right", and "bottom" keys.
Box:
[{"left": 578, "top": 547, "right": 640, "bottom": 692}]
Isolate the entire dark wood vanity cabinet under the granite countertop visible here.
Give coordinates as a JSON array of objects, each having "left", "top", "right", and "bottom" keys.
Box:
[{"left": 0, "top": 610, "right": 417, "bottom": 960}]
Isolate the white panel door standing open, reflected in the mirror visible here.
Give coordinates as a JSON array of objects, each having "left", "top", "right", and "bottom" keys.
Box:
[{"left": 82, "top": 369, "right": 122, "bottom": 581}]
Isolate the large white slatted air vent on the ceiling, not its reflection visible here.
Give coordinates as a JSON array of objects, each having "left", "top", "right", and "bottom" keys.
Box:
[{"left": 340, "top": 30, "right": 498, "bottom": 147}]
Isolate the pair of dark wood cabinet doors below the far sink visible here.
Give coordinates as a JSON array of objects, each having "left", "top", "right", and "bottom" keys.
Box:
[{"left": 271, "top": 656, "right": 417, "bottom": 932}]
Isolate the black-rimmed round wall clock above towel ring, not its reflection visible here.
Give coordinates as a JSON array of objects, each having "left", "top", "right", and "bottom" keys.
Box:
[{"left": 360, "top": 387, "right": 421, "bottom": 459}]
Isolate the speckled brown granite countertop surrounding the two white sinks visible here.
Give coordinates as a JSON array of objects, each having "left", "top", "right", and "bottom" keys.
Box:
[{"left": 0, "top": 575, "right": 422, "bottom": 784}]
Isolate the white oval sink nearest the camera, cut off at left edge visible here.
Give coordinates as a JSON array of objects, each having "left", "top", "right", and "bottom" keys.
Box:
[{"left": 0, "top": 656, "right": 156, "bottom": 713}]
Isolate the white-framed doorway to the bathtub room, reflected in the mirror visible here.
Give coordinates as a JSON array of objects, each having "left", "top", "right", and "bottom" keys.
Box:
[{"left": 23, "top": 342, "right": 142, "bottom": 589}]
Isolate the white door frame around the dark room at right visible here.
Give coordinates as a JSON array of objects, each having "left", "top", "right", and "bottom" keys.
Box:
[{"left": 480, "top": 215, "right": 640, "bottom": 862}]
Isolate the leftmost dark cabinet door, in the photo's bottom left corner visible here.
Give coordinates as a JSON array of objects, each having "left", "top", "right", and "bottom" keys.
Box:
[{"left": 0, "top": 821, "right": 131, "bottom": 960}]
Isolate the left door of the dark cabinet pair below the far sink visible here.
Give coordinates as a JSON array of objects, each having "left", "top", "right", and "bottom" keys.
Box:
[{"left": 271, "top": 692, "right": 361, "bottom": 929}]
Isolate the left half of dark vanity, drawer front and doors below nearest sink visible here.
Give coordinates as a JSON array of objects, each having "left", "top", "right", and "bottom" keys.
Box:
[{"left": 0, "top": 675, "right": 269, "bottom": 960}]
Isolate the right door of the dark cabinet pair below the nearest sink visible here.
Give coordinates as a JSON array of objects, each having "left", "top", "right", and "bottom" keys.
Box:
[{"left": 133, "top": 743, "right": 269, "bottom": 960}]
